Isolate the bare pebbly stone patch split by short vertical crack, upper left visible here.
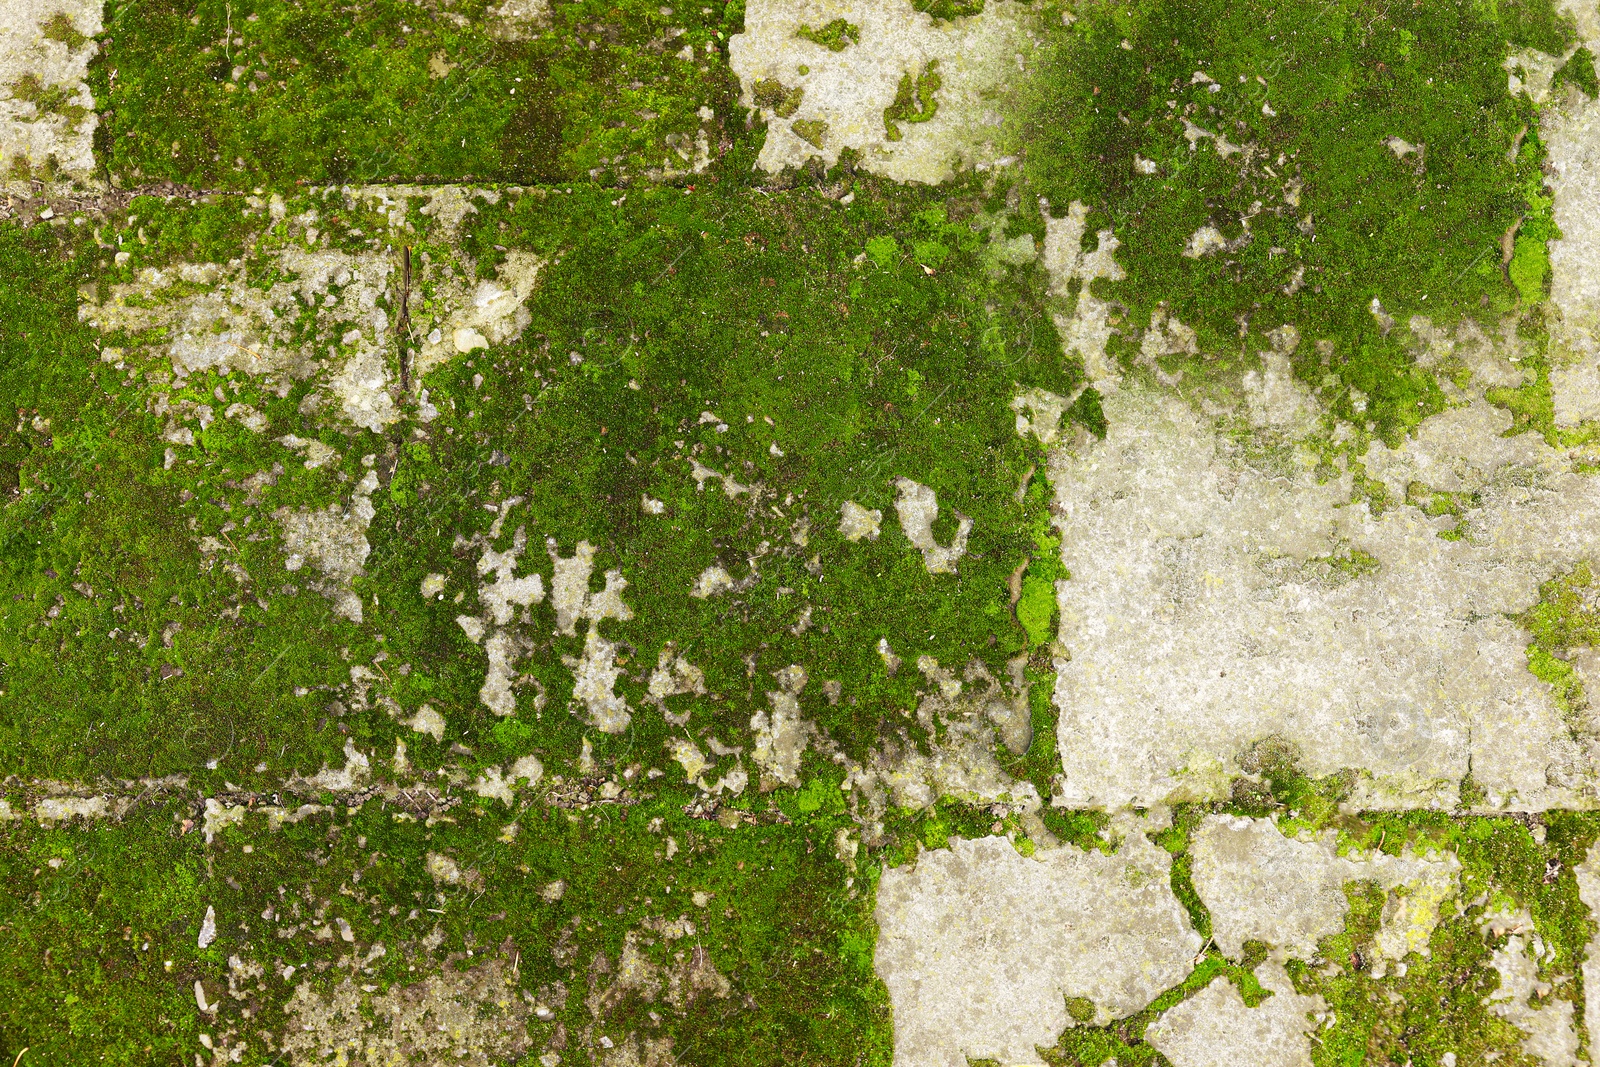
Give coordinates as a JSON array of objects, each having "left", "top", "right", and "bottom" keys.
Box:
[{"left": 78, "top": 186, "right": 544, "bottom": 435}]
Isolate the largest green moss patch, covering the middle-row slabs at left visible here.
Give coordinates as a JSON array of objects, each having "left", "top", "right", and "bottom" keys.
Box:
[{"left": 0, "top": 177, "right": 1074, "bottom": 811}]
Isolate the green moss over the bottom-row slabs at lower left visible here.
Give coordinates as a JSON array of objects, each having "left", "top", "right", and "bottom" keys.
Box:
[{"left": 0, "top": 793, "right": 890, "bottom": 1067}]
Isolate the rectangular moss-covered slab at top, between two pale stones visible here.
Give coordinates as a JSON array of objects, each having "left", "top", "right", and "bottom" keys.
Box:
[{"left": 91, "top": 0, "right": 747, "bottom": 189}]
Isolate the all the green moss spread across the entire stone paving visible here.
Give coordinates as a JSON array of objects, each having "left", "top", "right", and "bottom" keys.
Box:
[{"left": 0, "top": 0, "right": 1600, "bottom": 1067}]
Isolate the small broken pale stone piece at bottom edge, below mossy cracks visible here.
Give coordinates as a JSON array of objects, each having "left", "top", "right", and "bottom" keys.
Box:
[{"left": 1144, "top": 960, "right": 1326, "bottom": 1067}]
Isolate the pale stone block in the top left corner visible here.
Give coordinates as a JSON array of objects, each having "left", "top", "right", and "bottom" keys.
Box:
[{"left": 0, "top": 0, "right": 101, "bottom": 184}]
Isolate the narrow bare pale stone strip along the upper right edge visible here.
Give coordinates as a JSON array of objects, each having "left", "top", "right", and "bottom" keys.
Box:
[{"left": 1539, "top": 0, "right": 1600, "bottom": 426}]
